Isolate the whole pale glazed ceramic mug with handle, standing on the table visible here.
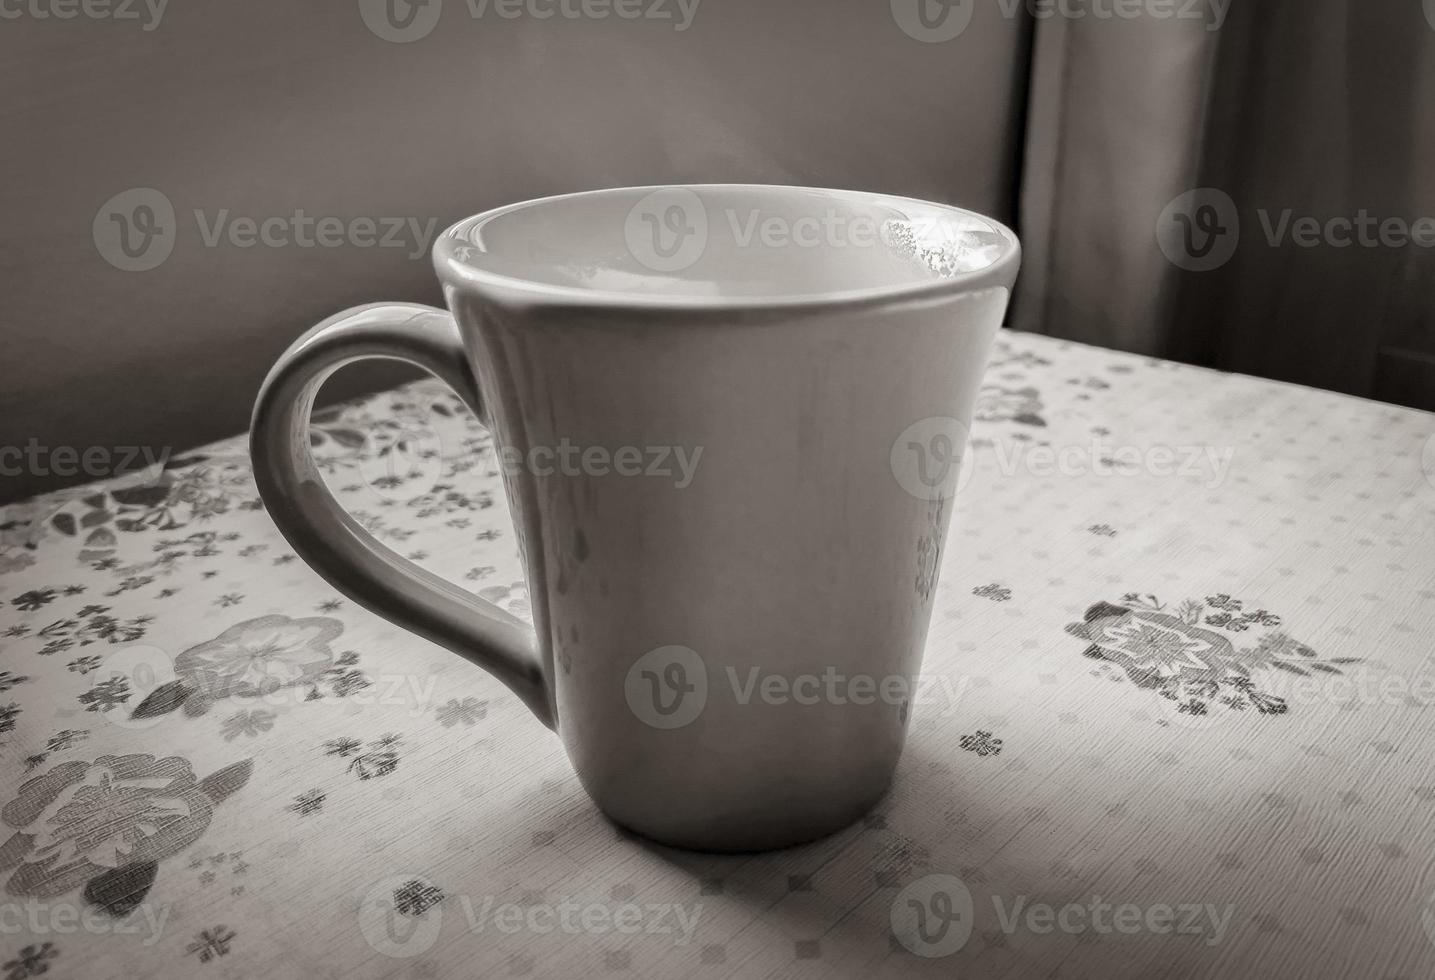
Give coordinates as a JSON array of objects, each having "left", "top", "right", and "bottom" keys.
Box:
[{"left": 251, "top": 185, "right": 1019, "bottom": 851}]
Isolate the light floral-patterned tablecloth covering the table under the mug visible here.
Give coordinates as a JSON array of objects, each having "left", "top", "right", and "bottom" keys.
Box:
[{"left": 0, "top": 333, "right": 1435, "bottom": 980}]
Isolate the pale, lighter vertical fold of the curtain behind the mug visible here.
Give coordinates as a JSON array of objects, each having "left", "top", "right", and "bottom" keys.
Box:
[{"left": 1015, "top": 9, "right": 1220, "bottom": 353}]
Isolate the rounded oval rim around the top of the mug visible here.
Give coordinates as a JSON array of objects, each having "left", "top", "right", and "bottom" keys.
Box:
[{"left": 432, "top": 184, "right": 1022, "bottom": 313}]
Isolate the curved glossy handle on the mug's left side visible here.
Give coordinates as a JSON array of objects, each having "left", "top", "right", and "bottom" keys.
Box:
[{"left": 250, "top": 303, "right": 555, "bottom": 729}]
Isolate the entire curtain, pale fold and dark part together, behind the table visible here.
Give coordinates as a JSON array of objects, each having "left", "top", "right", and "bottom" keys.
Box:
[{"left": 1013, "top": 0, "right": 1435, "bottom": 409}]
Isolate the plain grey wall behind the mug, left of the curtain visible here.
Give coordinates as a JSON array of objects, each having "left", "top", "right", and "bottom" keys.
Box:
[{"left": 0, "top": 0, "right": 1026, "bottom": 501}]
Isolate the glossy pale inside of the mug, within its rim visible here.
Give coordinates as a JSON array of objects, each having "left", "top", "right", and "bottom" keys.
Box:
[{"left": 435, "top": 184, "right": 1017, "bottom": 306}]
